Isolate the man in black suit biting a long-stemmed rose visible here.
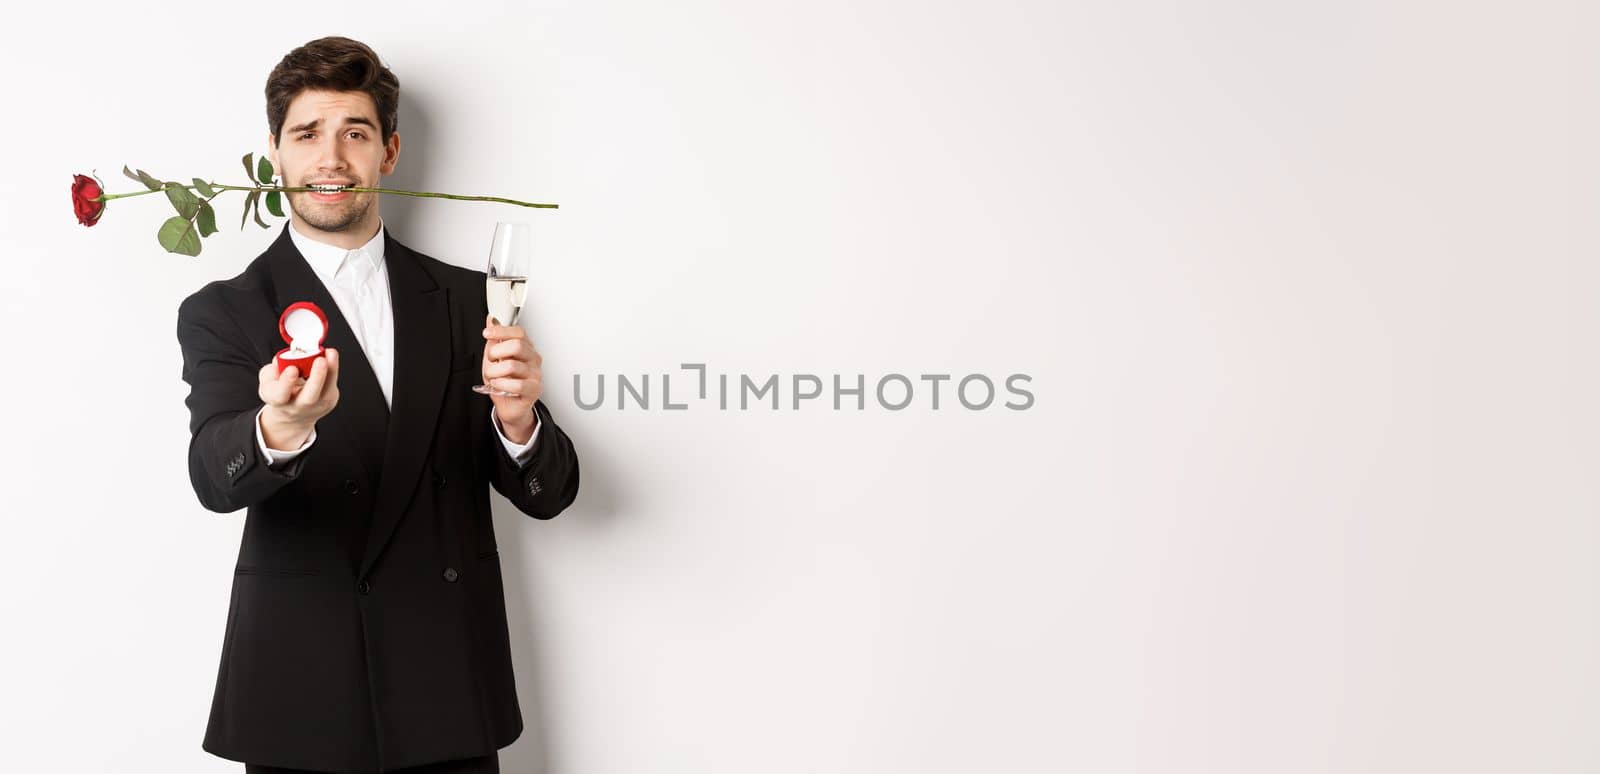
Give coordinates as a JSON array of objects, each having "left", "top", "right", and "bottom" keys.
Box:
[{"left": 178, "top": 37, "right": 578, "bottom": 774}]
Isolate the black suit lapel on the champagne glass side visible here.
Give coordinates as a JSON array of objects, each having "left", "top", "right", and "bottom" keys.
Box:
[{"left": 360, "top": 229, "right": 450, "bottom": 577}]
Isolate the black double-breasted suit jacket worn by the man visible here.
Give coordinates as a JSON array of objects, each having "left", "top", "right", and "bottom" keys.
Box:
[{"left": 178, "top": 224, "right": 578, "bottom": 771}]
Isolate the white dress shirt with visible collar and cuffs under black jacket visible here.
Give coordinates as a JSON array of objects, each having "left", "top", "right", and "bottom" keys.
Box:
[{"left": 256, "top": 217, "right": 539, "bottom": 467}]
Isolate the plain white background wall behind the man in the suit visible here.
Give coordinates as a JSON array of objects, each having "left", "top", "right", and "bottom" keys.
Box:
[{"left": 0, "top": 0, "right": 1600, "bottom": 774}]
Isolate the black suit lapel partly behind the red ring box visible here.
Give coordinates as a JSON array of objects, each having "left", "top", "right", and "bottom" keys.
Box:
[{"left": 267, "top": 224, "right": 389, "bottom": 486}]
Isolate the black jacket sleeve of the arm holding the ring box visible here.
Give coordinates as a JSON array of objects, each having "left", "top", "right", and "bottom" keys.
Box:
[{"left": 178, "top": 291, "right": 317, "bottom": 513}]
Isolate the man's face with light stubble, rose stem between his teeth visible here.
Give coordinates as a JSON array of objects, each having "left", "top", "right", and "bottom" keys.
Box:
[{"left": 267, "top": 90, "right": 400, "bottom": 235}]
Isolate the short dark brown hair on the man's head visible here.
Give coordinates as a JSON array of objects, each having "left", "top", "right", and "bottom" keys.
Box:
[{"left": 267, "top": 35, "right": 400, "bottom": 142}]
